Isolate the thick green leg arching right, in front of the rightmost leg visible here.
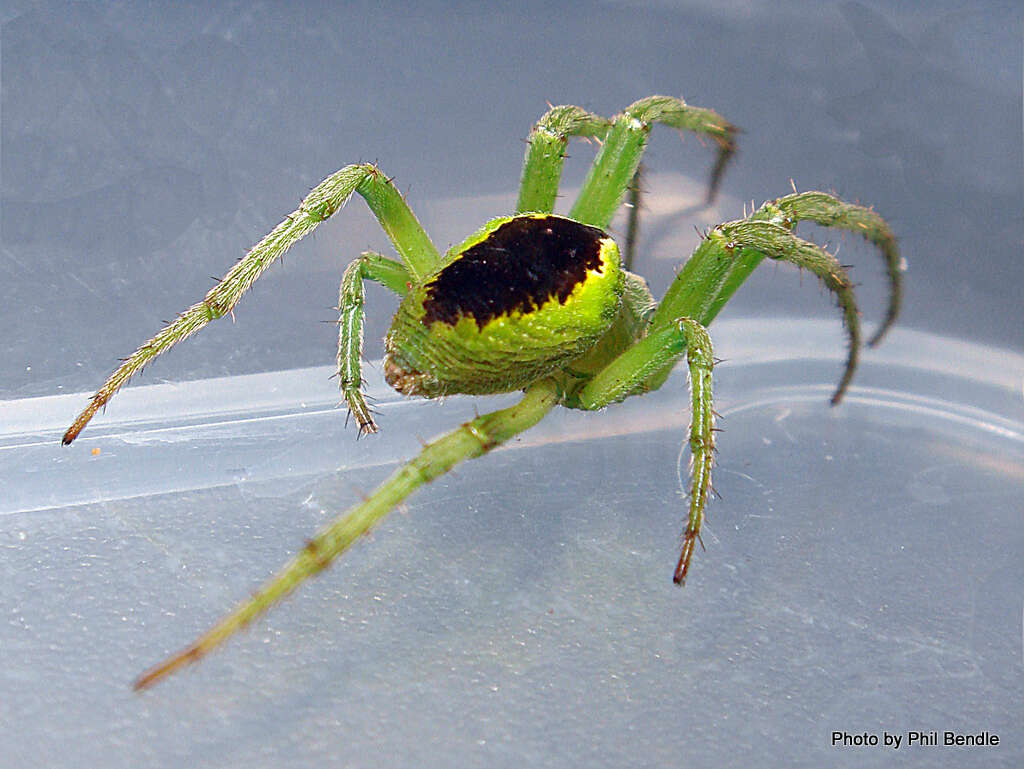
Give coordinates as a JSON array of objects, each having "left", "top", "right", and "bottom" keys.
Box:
[{"left": 648, "top": 219, "right": 860, "bottom": 404}]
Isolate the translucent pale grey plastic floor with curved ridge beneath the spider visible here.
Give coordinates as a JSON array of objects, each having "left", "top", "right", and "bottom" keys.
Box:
[{"left": 0, "top": 321, "right": 1024, "bottom": 766}]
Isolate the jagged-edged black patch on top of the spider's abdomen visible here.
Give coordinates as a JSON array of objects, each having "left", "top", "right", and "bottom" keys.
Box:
[{"left": 423, "top": 216, "right": 606, "bottom": 329}]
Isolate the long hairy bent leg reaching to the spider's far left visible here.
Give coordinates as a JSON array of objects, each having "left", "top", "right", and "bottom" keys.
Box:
[{"left": 61, "top": 164, "right": 440, "bottom": 445}]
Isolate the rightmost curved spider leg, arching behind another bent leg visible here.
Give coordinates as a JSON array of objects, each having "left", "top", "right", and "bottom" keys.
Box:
[{"left": 751, "top": 190, "right": 903, "bottom": 347}]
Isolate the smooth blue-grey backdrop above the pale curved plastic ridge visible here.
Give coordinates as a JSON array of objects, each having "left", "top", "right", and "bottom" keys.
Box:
[{"left": 0, "top": 2, "right": 1024, "bottom": 397}]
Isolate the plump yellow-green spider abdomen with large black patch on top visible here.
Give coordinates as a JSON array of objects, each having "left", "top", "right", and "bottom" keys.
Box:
[{"left": 384, "top": 214, "right": 624, "bottom": 397}]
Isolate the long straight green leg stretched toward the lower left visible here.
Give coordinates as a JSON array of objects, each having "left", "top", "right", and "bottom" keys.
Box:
[{"left": 134, "top": 379, "right": 557, "bottom": 690}]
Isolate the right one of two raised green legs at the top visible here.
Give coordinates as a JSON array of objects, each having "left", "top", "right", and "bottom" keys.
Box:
[{"left": 569, "top": 96, "right": 736, "bottom": 229}]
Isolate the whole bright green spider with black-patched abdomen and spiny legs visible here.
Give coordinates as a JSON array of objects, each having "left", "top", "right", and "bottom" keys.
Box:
[{"left": 62, "top": 96, "right": 900, "bottom": 689}]
